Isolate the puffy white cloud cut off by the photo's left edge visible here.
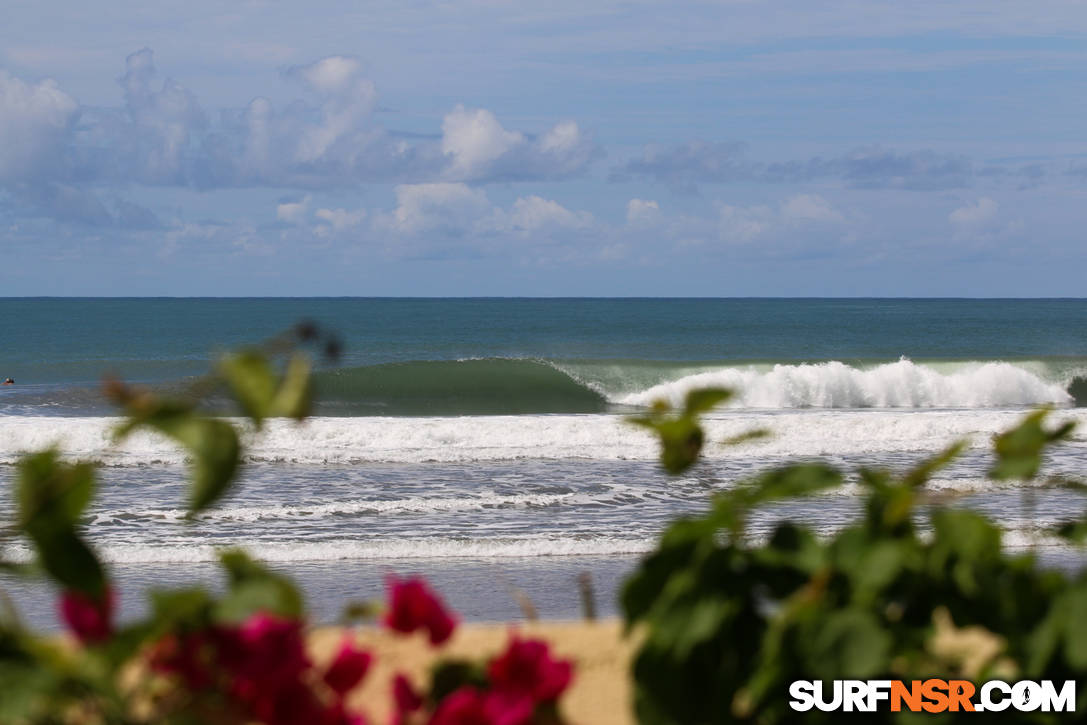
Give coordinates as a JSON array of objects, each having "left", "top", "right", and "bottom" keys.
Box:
[{"left": 0, "top": 71, "right": 79, "bottom": 182}]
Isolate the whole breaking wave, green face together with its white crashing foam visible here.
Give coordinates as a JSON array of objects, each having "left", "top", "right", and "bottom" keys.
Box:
[{"left": 0, "top": 358, "right": 1087, "bottom": 417}]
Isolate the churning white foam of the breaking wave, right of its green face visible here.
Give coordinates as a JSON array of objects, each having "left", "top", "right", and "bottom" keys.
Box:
[{"left": 617, "top": 358, "right": 1073, "bottom": 409}]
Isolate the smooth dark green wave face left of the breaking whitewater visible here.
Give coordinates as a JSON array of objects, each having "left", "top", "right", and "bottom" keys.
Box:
[{"left": 314, "top": 359, "right": 608, "bottom": 415}]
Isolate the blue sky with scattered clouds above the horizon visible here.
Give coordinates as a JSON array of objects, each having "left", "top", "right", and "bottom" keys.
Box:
[{"left": 0, "top": 0, "right": 1087, "bottom": 297}]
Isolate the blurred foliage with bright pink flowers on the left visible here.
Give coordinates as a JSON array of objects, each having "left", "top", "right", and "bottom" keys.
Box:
[{"left": 0, "top": 325, "right": 573, "bottom": 725}]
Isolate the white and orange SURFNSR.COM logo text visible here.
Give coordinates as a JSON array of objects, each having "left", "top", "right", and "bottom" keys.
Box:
[{"left": 789, "top": 679, "right": 1076, "bottom": 712}]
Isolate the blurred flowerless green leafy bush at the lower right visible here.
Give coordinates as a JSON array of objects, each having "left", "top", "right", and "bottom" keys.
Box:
[{"left": 622, "top": 400, "right": 1087, "bottom": 725}]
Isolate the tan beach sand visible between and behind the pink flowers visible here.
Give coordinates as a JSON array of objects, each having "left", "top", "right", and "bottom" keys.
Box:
[{"left": 310, "top": 620, "right": 635, "bottom": 725}]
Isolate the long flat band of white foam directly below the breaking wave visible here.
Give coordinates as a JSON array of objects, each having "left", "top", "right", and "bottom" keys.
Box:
[{"left": 0, "top": 409, "right": 1087, "bottom": 465}]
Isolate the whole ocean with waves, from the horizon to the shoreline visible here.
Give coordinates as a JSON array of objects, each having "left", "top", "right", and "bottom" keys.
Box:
[{"left": 0, "top": 298, "right": 1087, "bottom": 628}]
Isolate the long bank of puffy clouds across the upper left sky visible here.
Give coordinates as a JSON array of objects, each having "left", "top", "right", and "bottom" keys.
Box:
[{"left": 0, "top": 48, "right": 600, "bottom": 223}]
